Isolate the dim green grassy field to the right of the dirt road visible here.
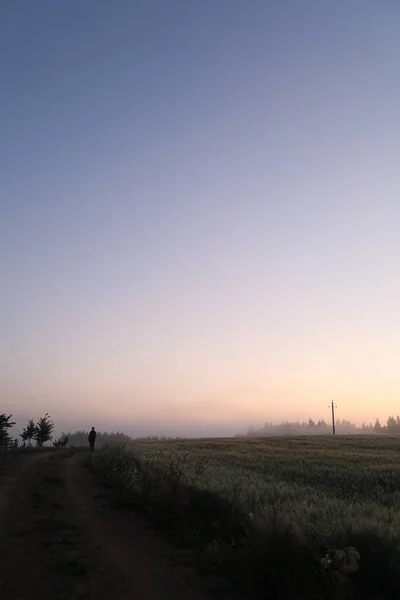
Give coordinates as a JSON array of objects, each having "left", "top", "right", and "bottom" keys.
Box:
[{"left": 92, "top": 436, "right": 400, "bottom": 600}]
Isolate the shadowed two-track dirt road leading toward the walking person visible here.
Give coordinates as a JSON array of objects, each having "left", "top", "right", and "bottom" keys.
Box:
[{"left": 0, "top": 451, "right": 220, "bottom": 600}]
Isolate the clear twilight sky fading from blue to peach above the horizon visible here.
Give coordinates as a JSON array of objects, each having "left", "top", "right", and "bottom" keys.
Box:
[{"left": 0, "top": 0, "right": 400, "bottom": 433}]
